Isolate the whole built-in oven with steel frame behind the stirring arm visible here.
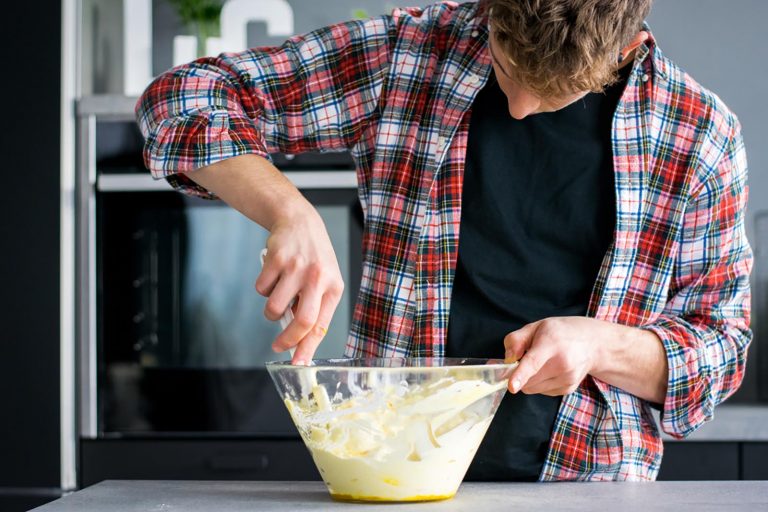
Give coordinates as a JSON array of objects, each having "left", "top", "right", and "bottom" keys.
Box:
[{"left": 78, "top": 98, "right": 362, "bottom": 485}]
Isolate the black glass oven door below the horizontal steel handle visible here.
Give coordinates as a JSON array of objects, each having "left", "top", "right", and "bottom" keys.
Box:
[{"left": 96, "top": 183, "right": 362, "bottom": 438}]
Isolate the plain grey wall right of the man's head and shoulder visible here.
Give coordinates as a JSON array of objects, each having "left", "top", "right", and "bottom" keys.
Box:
[{"left": 648, "top": 0, "right": 768, "bottom": 400}]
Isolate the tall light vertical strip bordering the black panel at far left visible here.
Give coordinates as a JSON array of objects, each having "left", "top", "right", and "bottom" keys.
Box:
[{"left": 60, "top": 0, "right": 81, "bottom": 495}]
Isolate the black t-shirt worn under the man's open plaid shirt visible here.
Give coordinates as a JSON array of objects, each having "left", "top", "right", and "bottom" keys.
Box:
[{"left": 446, "top": 66, "right": 631, "bottom": 481}]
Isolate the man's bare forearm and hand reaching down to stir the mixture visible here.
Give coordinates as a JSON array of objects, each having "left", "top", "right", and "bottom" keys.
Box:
[{"left": 187, "top": 155, "right": 344, "bottom": 364}]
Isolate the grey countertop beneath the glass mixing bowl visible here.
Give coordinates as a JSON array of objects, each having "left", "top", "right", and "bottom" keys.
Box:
[{"left": 35, "top": 480, "right": 768, "bottom": 512}]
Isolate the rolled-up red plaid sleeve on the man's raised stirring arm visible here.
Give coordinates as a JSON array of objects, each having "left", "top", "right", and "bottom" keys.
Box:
[{"left": 136, "top": 14, "right": 397, "bottom": 198}]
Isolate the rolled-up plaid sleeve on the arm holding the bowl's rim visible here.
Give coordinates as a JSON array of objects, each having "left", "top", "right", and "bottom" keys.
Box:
[{"left": 644, "top": 119, "right": 752, "bottom": 438}]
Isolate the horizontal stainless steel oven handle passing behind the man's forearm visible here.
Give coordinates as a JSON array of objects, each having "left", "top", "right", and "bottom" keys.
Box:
[{"left": 96, "top": 170, "right": 357, "bottom": 192}]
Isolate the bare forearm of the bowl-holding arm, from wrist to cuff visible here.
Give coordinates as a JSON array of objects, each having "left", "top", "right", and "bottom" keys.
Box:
[{"left": 590, "top": 324, "right": 669, "bottom": 404}]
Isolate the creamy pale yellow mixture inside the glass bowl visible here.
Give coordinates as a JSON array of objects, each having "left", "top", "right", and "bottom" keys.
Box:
[{"left": 285, "top": 372, "right": 507, "bottom": 501}]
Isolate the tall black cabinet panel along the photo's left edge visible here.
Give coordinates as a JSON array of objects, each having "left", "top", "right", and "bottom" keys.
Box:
[{"left": 0, "top": 1, "right": 62, "bottom": 512}]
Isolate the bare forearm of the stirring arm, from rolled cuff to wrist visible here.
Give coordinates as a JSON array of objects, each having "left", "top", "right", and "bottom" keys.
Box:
[{"left": 187, "top": 155, "right": 313, "bottom": 231}]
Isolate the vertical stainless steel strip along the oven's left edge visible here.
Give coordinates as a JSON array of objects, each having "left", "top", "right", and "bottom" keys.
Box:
[{"left": 76, "top": 115, "right": 97, "bottom": 438}]
